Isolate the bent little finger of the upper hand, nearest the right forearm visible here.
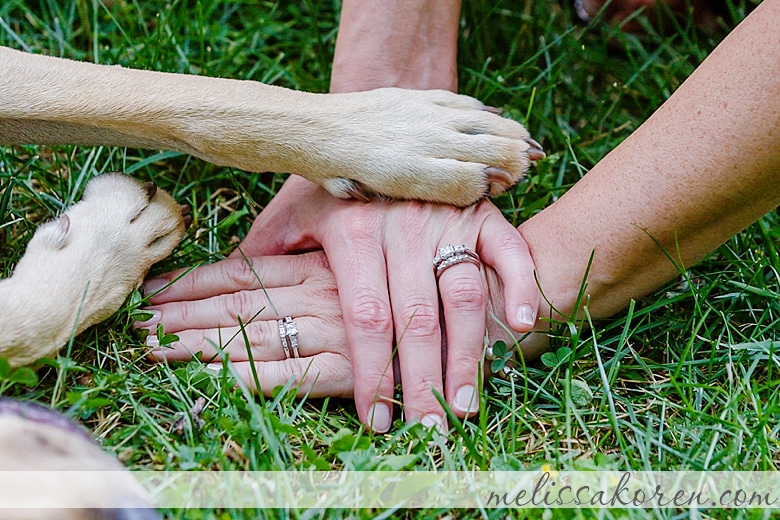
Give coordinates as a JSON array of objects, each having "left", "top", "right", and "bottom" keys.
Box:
[{"left": 477, "top": 209, "right": 541, "bottom": 333}]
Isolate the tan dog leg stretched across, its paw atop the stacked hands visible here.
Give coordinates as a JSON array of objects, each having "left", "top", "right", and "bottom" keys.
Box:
[{"left": 0, "top": 47, "right": 544, "bottom": 206}]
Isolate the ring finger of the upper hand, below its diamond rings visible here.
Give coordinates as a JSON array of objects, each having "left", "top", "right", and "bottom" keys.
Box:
[{"left": 439, "top": 251, "right": 487, "bottom": 417}]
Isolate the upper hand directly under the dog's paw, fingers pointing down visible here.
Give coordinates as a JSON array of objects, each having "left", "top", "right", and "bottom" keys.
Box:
[{"left": 233, "top": 177, "right": 540, "bottom": 432}]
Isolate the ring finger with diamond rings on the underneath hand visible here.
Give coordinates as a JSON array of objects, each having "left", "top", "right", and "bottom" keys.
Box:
[{"left": 146, "top": 317, "right": 346, "bottom": 363}]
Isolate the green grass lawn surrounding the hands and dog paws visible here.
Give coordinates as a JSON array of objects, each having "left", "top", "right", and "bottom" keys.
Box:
[{"left": 0, "top": 0, "right": 780, "bottom": 518}]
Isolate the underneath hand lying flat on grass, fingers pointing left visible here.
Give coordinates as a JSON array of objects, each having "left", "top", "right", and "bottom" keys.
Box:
[{"left": 136, "top": 252, "right": 353, "bottom": 397}]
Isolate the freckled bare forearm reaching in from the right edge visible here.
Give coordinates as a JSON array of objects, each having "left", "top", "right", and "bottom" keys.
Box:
[{"left": 519, "top": 0, "right": 780, "bottom": 317}]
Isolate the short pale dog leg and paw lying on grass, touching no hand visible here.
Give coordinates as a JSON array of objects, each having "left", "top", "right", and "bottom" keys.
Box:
[{"left": 0, "top": 173, "right": 189, "bottom": 366}]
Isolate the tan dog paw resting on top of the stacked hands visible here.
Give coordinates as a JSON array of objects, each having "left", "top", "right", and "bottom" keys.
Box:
[{"left": 311, "top": 88, "right": 545, "bottom": 206}]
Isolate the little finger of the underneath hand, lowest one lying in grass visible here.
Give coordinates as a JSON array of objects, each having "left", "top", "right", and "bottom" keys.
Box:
[{"left": 216, "top": 353, "right": 354, "bottom": 398}]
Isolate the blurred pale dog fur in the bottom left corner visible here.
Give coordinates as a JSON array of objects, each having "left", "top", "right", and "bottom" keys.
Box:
[{"left": 0, "top": 398, "right": 159, "bottom": 520}]
